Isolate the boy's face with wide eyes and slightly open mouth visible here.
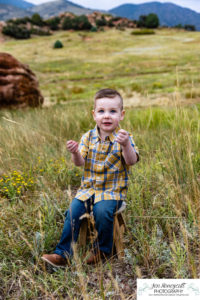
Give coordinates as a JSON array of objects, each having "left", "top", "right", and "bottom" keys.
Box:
[{"left": 93, "top": 96, "right": 125, "bottom": 135}]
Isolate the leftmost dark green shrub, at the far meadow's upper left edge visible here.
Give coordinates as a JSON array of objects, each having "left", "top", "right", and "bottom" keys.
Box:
[{"left": 2, "top": 25, "right": 31, "bottom": 39}]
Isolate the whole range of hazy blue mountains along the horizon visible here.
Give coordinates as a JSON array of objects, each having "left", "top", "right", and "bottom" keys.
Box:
[{"left": 0, "top": 0, "right": 200, "bottom": 31}]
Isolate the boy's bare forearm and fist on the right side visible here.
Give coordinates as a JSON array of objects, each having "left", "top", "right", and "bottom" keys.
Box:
[{"left": 116, "top": 129, "right": 138, "bottom": 166}]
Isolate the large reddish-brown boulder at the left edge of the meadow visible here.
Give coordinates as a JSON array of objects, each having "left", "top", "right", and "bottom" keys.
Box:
[{"left": 0, "top": 53, "right": 44, "bottom": 108}]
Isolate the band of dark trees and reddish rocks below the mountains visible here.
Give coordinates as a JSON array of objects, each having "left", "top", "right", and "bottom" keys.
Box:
[{"left": 2, "top": 13, "right": 196, "bottom": 39}]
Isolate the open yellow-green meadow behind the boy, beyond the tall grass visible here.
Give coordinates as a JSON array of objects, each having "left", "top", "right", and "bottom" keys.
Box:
[{"left": 0, "top": 29, "right": 200, "bottom": 103}]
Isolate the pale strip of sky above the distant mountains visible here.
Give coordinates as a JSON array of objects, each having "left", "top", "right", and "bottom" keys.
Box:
[{"left": 26, "top": 0, "right": 200, "bottom": 12}]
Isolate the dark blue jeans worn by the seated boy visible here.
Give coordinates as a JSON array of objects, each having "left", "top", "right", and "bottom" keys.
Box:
[{"left": 54, "top": 196, "right": 123, "bottom": 258}]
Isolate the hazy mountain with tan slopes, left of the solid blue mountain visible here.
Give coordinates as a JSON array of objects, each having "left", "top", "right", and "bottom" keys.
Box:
[{"left": 30, "top": 0, "right": 92, "bottom": 19}]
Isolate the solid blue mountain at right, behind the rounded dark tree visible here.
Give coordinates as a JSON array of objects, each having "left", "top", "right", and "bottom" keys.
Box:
[{"left": 109, "top": 2, "right": 200, "bottom": 30}]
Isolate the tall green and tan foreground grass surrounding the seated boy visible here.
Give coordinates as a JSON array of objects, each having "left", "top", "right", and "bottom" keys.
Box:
[{"left": 0, "top": 103, "right": 200, "bottom": 299}]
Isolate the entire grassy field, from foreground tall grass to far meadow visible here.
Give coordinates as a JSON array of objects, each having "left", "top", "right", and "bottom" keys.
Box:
[{"left": 0, "top": 30, "right": 200, "bottom": 299}]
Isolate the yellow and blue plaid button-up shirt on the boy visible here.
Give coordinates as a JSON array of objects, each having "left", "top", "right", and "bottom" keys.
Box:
[{"left": 75, "top": 126, "right": 139, "bottom": 203}]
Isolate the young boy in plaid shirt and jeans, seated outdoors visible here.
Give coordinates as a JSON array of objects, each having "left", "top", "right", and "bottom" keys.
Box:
[{"left": 42, "top": 89, "right": 139, "bottom": 267}]
